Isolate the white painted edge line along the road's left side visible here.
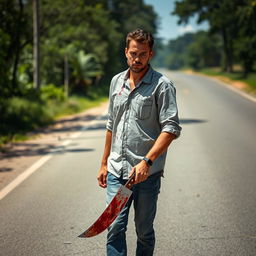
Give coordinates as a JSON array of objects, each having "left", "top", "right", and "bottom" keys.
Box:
[{"left": 0, "top": 109, "right": 107, "bottom": 200}]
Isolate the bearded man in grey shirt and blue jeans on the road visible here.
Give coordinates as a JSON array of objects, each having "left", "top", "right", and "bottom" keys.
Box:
[{"left": 97, "top": 29, "right": 181, "bottom": 256}]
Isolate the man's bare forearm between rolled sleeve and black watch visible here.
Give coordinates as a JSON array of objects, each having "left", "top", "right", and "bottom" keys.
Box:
[{"left": 146, "top": 132, "right": 176, "bottom": 162}]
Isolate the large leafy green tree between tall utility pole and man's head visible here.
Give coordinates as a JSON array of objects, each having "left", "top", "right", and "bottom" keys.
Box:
[{"left": 39, "top": 0, "right": 121, "bottom": 90}]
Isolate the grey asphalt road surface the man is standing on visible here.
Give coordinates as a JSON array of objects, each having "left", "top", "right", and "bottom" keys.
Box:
[{"left": 0, "top": 72, "right": 256, "bottom": 256}]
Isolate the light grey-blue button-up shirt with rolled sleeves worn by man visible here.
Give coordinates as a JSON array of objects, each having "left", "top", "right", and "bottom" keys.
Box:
[{"left": 107, "top": 67, "right": 181, "bottom": 179}]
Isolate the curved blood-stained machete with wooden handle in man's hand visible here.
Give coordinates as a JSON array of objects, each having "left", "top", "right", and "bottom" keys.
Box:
[{"left": 78, "top": 172, "right": 135, "bottom": 238}]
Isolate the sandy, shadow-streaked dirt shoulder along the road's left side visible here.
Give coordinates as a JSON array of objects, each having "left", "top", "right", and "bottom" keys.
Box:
[{"left": 0, "top": 102, "right": 108, "bottom": 191}]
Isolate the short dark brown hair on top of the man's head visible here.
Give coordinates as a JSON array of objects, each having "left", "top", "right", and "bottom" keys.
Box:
[{"left": 126, "top": 29, "right": 154, "bottom": 50}]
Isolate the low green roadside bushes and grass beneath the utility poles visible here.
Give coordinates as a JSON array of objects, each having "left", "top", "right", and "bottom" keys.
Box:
[{"left": 0, "top": 85, "right": 107, "bottom": 145}]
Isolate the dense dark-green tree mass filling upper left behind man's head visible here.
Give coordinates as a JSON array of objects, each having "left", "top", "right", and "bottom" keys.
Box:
[{"left": 0, "top": 0, "right": 157, "bottom": 97}]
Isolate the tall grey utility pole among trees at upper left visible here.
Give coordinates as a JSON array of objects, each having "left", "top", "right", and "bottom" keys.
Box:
[{"left": 33, "top": 0, "right": 40, "bottom": 90}]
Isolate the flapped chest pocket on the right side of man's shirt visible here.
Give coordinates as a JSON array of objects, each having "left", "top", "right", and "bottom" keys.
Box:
[{"left": 134, "top": 97, "right": 153, "bottom": 120}]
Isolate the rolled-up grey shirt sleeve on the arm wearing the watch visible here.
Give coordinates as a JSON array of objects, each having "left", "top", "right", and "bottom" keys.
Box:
[{"left": 157, "top": 81, "right": 182, "bottom": 138}]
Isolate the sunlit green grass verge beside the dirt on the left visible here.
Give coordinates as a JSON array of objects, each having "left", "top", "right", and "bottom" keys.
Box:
[{"left": 0, "top": 89, "right": 108, "bottom": 148}]
